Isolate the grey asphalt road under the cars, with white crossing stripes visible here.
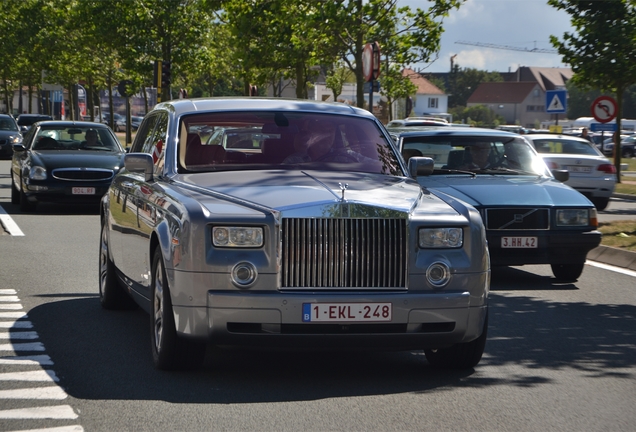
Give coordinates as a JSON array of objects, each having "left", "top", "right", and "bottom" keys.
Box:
[{"left": 0, "top": 161, "right": 636, "bottom": 431}]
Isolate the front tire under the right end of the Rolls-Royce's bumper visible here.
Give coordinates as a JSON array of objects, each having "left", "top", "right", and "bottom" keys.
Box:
[{"left": 424, "top": 313, "right": 488, "bottom": 369}]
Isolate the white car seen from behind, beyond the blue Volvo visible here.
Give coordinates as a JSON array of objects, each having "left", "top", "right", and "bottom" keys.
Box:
[{"left": 526, "top": 134, "right": 616, "bottom": 210}]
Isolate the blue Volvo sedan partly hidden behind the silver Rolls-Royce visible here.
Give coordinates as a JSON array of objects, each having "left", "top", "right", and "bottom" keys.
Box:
[{"left": 397, "top": 127, "right": 601, "bottom": 282}]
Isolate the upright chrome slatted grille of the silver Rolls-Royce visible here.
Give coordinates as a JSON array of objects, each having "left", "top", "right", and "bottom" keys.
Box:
[{"left": 281, "top": 219, "right": 407, "bottom": 289}]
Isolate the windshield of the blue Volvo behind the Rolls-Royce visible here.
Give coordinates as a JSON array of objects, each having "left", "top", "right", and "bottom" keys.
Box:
[{"left": 402, "top": 134, "right": 550, "bottom": 176}]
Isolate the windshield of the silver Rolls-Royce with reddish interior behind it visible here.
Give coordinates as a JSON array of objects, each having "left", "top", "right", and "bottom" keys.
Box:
[{"left": 179, "top": 112, "right": 404, "bottom": 176}]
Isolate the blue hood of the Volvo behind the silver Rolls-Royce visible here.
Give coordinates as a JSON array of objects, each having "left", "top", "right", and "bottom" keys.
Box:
[{"left": 418, "top": 175, "right": 592, "bottom": 207}]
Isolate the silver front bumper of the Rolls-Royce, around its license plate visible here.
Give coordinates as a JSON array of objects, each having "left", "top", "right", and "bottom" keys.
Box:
[{"left": 166, "top": 272, "right": 489, "bottom": 349}]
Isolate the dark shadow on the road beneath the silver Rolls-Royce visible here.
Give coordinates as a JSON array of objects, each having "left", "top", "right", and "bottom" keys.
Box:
[{"left": 18, "top": 288, "right": 636, "bottom": 404}]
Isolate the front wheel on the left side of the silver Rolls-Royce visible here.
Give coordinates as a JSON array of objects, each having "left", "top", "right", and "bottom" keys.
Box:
[{"left": 150, "top": 248, "right": 206, "bottom": 370}]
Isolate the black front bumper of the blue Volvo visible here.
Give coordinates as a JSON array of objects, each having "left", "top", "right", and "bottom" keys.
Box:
[{"left": 486, "top": 231, "right": 601, "bottom": 266}]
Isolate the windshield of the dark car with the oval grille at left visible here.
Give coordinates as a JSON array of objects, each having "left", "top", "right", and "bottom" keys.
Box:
[{"left": 32, "top": 125, "right": 123, "bottom": 152}]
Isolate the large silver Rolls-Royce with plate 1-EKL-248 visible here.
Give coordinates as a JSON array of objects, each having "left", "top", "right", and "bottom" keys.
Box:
[{"left": 99, "top": 98, "right": 490, "bottom": 369}]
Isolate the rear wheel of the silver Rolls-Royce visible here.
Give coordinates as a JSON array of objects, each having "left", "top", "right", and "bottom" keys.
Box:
[{"left": 99, "top": 221, "right": 137, "bottom": 310}]
